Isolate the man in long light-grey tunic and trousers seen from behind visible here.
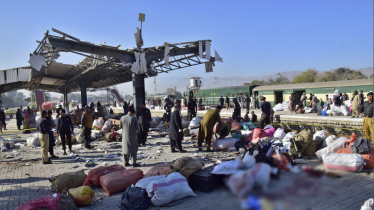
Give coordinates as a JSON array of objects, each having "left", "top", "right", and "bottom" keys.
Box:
[{"left": 119, "top": 108, "right": 140, "bottom": 167}]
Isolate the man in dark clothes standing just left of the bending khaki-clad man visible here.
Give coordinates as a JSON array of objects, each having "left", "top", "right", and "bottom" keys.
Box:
[{"left": 169, "top": 104, "right": 187, "bottom": 153}]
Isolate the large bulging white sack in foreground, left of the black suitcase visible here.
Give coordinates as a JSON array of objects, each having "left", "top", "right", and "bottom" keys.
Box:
[{"left": 147, "top": 172, "right": 196, "bottom": 206}]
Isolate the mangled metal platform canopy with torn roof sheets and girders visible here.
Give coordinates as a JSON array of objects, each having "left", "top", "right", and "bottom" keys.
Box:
[{"left": 0, "top": 29, "right": 222, "bottom": 109}]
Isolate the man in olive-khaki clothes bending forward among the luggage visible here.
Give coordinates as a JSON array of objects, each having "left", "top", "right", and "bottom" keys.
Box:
[{"left": 197, "top": 106, "right": 222, "bottom": 152}]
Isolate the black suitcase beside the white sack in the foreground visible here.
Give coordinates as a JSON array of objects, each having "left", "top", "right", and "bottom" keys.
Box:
[{"left": 189, "top": 165, "right": 224, "bottom": 193}]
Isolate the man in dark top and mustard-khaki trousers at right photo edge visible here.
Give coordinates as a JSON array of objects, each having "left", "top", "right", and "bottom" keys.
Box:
[{"left": 361, "top": 92, "right": 373, "bottom": 142}]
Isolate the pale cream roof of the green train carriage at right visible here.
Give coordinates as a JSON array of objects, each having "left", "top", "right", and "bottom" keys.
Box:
[{"left": 253, "top": 79, "right": 373, "bottom": 91}]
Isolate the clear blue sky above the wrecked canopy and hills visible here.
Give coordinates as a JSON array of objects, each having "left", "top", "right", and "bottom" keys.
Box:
[{"left": 0, "top": 0, "right": 373, "bottom": 95}]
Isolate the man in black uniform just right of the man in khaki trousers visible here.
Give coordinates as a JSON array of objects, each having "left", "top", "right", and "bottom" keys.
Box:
[{"left": 57, "top": 109, "right": 74, "bottom": 155}]
